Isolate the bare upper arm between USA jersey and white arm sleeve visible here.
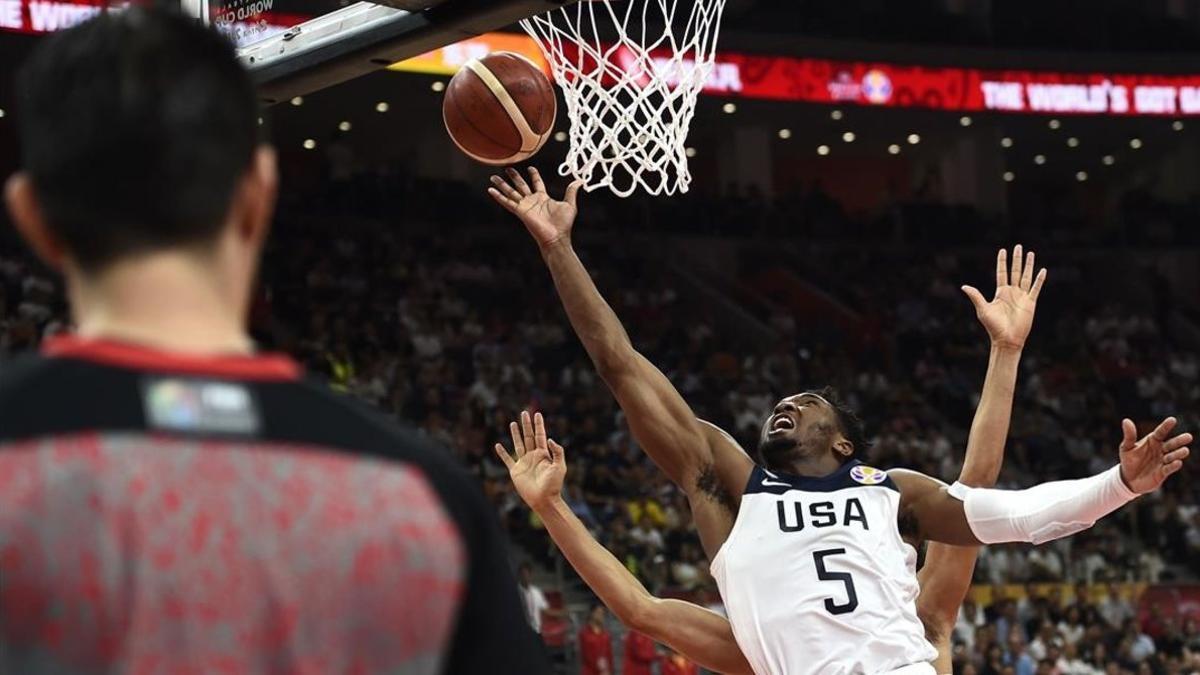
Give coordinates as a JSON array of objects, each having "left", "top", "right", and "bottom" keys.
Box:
[{"left": 888, "top": 468, "right": 980, "bottom": 546}]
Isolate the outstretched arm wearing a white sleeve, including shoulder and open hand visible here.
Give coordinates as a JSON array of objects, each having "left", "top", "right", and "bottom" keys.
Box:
[{"left": 890, "top": 417, "right": 1192, "bottom": 545}]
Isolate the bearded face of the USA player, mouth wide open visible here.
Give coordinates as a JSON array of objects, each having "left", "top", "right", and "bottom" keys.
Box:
[{"left": 758, "top": 392, "right": 839, "bottom": 472}]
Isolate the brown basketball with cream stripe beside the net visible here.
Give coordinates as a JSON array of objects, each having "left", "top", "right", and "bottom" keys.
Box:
[{"left": 442, "top": 52, "right": 558, "bottom": 166}]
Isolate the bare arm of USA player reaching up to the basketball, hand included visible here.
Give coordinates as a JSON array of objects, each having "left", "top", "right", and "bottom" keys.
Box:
[{"left": 488, "top": 168, "right": 754, "bottom": 556}]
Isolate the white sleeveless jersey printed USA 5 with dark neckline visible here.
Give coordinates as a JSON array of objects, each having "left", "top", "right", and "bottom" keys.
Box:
[{"left": 712, "top": 461, "right": 937, "bottom": 675}]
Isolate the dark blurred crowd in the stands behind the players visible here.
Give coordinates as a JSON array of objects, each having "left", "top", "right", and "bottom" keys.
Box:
[{"left": 0, "top": 169, "right": 1200, "bottom": 675}]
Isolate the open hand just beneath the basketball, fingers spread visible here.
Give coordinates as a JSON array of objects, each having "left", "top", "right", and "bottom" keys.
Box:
[{"left": 487, "top": 167, "right": 583, "bottom": 250}]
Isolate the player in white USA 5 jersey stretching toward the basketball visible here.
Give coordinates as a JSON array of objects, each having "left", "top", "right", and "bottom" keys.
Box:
[{"left": 490, "top": 171, "right": 1192, "bottom": 675}]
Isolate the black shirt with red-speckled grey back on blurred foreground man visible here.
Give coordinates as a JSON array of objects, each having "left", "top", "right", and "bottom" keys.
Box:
[{"left": 0, "top": 338, "right": 548, "bottom": 675}]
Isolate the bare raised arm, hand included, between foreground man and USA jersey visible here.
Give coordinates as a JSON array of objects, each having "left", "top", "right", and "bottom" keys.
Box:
[{"left": 496, "top": 412, "right": 752, "bottom": 675}]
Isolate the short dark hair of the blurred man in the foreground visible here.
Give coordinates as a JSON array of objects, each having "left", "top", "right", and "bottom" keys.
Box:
[{"left": 17, "top": 8, "right": 258, "bottom": 271}]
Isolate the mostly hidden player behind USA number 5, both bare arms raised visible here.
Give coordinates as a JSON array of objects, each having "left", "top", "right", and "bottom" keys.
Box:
[{"left": 496, "top": 239, "right": 1037, "bottom": 675}]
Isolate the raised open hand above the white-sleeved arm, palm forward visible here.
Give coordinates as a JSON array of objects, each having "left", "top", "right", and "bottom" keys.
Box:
[{"left": 962, "top": 244, "right": 1046, "bottom": 350}]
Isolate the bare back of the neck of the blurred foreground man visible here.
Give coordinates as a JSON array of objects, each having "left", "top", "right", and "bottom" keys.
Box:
[{"left": 67, "top": 247, "right": 253, "bottom": 354}]
